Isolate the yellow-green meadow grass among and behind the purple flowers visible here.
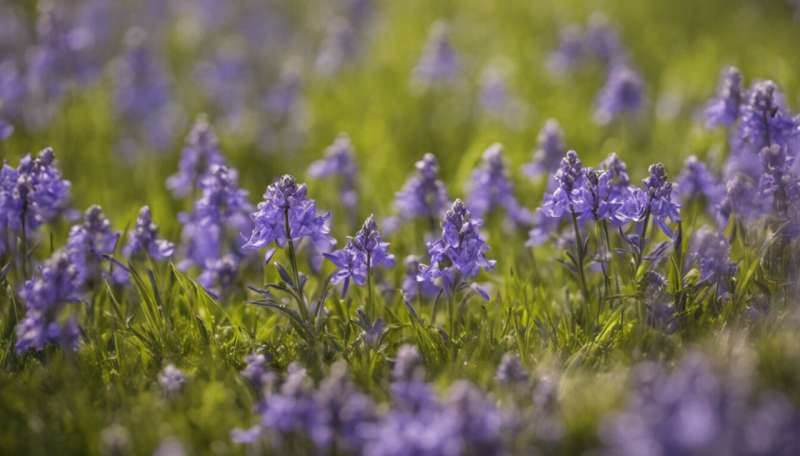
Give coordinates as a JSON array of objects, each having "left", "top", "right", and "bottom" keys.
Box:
[{"left": 0, "top": 0, "right": 800, "bottom": 454}]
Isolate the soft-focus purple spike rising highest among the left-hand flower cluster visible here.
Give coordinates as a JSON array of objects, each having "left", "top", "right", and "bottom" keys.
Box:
[{"left": 167, "top": 115, "right": 225, "bottom": 197}]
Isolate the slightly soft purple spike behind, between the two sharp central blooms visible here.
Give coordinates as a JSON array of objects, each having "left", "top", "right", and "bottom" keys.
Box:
[{"left": 394, "top": 154, "right": 448, "bottom": 226}]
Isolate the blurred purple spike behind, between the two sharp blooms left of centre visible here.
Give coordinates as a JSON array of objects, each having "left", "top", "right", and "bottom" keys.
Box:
[{"left": 308, "top": 133, "right": 358, "bottom": 219}]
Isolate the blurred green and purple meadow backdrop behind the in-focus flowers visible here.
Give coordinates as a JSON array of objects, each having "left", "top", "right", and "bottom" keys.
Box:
[{"left": 0, "top": 0, "right": 800, "bottom": 239}]
